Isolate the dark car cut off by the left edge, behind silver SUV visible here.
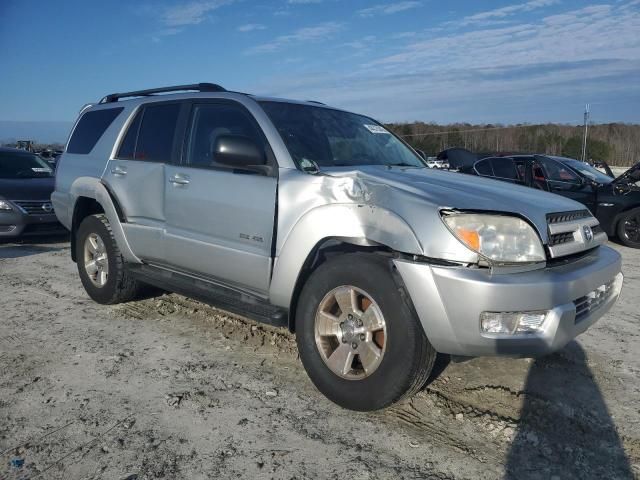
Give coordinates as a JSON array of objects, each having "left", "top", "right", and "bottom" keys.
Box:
[{"left": 0, "top": 148, "right": 66, "bottom": 239}]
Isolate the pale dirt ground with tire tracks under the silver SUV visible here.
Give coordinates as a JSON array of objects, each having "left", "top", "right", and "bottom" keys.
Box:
[{"left": 0, "top": 237, "right": 640, "bottom": 480}]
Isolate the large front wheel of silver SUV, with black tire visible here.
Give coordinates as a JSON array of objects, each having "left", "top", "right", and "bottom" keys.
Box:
[{"left": 296, "top": 253, "right": 436, "bottom": 411}]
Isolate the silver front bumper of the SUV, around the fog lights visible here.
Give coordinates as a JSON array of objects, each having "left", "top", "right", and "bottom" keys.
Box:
[{"left": 394, "top": 246, "right": 622, "bottom": 356}]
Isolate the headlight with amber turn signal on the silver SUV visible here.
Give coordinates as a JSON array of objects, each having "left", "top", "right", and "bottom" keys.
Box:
[{"left": 443, "top": 213, "right": 546, "bottom": 263}]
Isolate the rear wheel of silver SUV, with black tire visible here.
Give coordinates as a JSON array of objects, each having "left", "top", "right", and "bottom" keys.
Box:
[{"left": 75, "top": 214, "right": 142, "bottom": 305}]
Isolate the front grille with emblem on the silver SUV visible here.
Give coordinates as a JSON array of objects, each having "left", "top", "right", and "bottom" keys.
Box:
[{"left": 547, "top": 210, "right": 607, "bottom": 259}]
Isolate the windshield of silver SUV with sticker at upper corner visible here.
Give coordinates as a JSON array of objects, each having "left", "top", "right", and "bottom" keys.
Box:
[{"left": 261, "top": 102, "right": 425, "bottom": 170}]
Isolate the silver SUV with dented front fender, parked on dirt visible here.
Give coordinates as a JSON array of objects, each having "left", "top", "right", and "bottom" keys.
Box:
[{"left": 52, "top": 84, "right": 622, "bottom": 410}]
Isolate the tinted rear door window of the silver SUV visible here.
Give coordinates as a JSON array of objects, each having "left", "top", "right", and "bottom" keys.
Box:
[{"left": 135, "top": 103, "right": 180, "bottom": 162}]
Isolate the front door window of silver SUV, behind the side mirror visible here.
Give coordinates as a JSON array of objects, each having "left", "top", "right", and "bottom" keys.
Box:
[{"left": 187, "top": 104, "right": 265, "bottom": 167}]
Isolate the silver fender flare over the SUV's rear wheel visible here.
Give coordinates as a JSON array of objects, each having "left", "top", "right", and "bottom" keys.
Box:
[{"left": 69, "top": 177, "right": 142, "bottom": 263}]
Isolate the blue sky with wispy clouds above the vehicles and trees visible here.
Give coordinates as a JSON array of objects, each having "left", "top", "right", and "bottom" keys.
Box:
[{"left": 0, "top": 0, "right": 640, "bottom": 141}]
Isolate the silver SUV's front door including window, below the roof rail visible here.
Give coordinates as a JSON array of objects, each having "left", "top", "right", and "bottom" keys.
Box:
[{"left": 165, "top": 100, "right": 277, "bottom": 294}]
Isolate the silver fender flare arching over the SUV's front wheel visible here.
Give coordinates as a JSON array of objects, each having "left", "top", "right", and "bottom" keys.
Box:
[{"left": 269, "top": 204, "right": 423, "bottom": 308}]
